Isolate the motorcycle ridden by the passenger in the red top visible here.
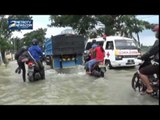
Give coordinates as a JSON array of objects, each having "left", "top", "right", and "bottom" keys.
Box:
[{"left": 84, "top": 52, "right": 107, "bottom": 77}]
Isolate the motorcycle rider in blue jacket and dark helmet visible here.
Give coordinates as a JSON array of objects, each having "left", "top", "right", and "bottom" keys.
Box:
[{"left": 28, "top": 39, "right": 45, "bottom": 79}]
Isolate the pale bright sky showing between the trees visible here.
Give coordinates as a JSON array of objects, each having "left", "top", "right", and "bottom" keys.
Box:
[{"left": 12, "top": 15, "right": 159, "bottom": 46}]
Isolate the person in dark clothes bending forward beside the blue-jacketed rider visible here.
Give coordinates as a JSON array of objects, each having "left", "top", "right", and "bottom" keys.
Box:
[{"left": 15, "top": 46, "right": 28, "bottom": 82}]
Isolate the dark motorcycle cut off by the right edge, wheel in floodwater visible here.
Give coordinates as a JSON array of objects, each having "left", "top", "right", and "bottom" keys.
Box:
[{"left": 131, "top": 58, "right": 159, "bottom": 98}]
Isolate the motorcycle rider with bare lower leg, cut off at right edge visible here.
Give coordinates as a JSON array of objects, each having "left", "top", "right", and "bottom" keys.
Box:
[{"left": 139, "top": 25, "right": 159, "bottom": 94}]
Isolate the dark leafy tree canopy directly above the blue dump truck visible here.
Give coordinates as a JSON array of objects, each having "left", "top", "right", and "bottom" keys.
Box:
[{"left": 49, "top": 15, "right": 97, "bottom": 36}]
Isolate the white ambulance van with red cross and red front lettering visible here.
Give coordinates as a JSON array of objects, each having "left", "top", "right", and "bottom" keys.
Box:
[{"left": 85, "top": 36, "right": 141, "bottom": 68}]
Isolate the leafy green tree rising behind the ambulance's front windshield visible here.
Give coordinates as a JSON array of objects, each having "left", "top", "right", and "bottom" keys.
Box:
[{"left": 114, "top": 15, "right": 152, "bottom": 46}]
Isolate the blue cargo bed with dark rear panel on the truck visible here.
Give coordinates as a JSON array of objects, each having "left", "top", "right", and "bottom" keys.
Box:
[{"left": 45, "top": 34, "right": 85, "bottom": 55}]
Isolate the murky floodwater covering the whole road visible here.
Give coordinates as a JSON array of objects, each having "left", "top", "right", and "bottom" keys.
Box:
[{"left": 0, "top": 61, "right": 159, "bottom": 105}]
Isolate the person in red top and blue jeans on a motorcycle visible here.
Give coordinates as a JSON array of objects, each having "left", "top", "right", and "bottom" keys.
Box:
[{"left": 87, "top": 44, "right": 105, "bottom": 74}]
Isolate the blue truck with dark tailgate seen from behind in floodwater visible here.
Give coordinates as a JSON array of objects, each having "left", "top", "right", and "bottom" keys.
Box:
[{"left": 44, "top": 34, "right": 86, "bottom": 69}]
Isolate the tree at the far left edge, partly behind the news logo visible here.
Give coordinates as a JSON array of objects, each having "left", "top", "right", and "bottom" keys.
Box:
[{"left": 0, "top": 15, "right": 31, "bottom": 63}]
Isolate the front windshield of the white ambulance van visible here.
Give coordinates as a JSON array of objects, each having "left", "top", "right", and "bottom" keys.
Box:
[{"left": 115, "top": 40, "right": 137, "bottom": 49}]
